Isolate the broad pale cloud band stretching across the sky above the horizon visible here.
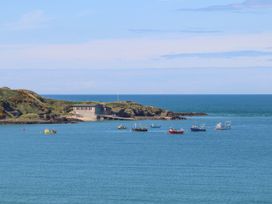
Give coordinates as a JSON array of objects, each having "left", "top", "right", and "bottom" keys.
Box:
[{"left": 0, "top": 33, "right": 272, "bottom": 69}]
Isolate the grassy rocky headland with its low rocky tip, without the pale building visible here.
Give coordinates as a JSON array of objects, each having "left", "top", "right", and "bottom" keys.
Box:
[{"left": 0, "top": 87, "right": 206, "bottom": 124}]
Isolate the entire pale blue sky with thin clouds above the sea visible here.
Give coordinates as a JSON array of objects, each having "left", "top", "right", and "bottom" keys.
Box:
[{"left": 0, "top": 0, "right": 272, "bottom": 94}]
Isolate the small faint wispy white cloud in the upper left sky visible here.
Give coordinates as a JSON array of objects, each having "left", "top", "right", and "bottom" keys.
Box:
[{"left": 4, "top": 10, "right": 50, "bottom": 30}]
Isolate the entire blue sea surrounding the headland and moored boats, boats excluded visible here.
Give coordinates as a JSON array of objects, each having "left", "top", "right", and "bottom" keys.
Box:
[{"left": 0, "top": 95, "right": 272, "bottom": 204}]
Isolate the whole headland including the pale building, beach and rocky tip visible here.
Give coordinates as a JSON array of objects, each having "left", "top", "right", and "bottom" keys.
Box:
[{"left": 0, "top": 87, "right": 207, "bottom": 124}]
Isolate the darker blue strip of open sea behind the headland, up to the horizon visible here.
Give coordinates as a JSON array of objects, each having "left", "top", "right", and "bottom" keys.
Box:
[{"left": 46, "top": 95, "right": 272, "bottom": 116}]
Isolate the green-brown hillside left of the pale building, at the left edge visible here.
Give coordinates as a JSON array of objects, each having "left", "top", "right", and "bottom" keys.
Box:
[{"left": 0, "top": 88, "right": 74, "bottom": 122}]
